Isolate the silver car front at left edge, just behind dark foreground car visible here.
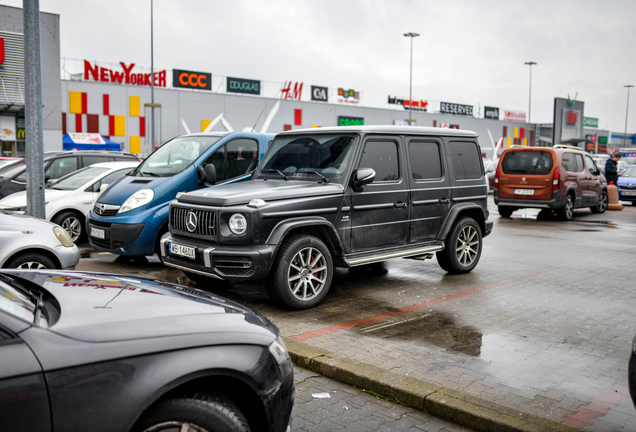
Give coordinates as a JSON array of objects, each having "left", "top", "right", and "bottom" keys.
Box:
[{"left": 0, "top": 209, "right": 80, "bottom": 268}]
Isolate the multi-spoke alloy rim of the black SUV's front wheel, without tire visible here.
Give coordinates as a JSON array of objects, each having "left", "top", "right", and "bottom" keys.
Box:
[{"left": 287, "top": 247, "right": 328, "bottom": 301}]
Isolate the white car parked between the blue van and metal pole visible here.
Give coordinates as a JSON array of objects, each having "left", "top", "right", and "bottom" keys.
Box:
[{"left": 0, "top": 162, "right": 139, "bottom": 243}]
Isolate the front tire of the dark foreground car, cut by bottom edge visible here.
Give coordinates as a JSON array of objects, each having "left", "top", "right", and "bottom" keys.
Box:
[{"left": 132, "top": 395, "right": 250, "bottom": 432}]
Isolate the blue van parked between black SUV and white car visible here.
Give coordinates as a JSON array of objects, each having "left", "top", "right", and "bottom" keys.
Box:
[{"left": 86, "top": 132, "right": 274, "bottom": 257}]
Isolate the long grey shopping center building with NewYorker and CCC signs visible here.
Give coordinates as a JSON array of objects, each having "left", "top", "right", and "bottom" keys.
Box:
[{"left": 0, "top": 5, "right": 634, "bottom": 157}]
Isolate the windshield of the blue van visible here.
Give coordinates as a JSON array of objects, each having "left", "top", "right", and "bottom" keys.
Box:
[{"left": 136, "top": 136, "right": 222, "bottom": 177}]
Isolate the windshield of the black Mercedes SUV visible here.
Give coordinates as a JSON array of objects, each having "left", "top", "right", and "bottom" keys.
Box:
[{"left": 259, "top": 134, "right": 355, "bottom": 180}]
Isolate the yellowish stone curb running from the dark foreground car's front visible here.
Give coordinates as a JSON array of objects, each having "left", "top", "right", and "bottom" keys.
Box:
[{"left": 283, "top": 337, "right": 578, "bottom": 432}]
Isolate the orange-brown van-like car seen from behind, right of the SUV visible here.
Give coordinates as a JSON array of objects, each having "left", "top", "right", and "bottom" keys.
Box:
[{"left": 495, "top": 145, "right": 608, "bottom": 221}]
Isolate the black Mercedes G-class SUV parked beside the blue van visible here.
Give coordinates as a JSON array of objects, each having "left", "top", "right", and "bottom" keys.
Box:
[{"left": 161, "top": 126, "right": 492, "bottom": 309}]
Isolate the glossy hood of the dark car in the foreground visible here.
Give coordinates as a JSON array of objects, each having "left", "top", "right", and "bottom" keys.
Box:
[{"left": 3, "top": 270, "right": 278, "bottom": 343}]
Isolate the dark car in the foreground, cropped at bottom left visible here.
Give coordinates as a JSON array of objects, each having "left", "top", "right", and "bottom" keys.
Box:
[{"left": 0, "top": 270, "right": 294, "bottom": 432}]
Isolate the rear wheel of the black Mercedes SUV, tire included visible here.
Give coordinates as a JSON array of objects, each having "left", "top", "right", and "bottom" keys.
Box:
[{"left": 437, "top": 217, "right": 482, "bottom": 274}]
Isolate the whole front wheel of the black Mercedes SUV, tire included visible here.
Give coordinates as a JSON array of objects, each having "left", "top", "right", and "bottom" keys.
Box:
[{"left": 265, "top": 234, "right": 333, "bottom": 310}]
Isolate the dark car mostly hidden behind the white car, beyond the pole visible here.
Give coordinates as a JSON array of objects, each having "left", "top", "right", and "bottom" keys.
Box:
[{"left": 0, "top": 150, "right": 141, "bottom": 198}]
